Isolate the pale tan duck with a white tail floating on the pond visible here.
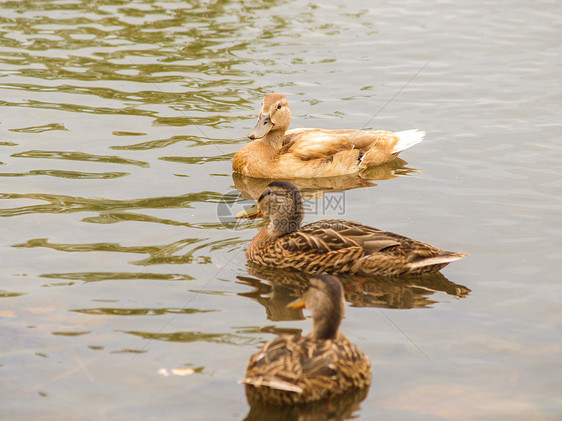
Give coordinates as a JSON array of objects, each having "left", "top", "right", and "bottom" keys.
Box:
[{"left": 232, "top": 93, "right": 425, "bottom": 178}]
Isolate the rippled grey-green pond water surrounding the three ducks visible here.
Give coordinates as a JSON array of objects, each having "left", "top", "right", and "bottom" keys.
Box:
[{"left": 0, "top": 0, "right": 562, "bottom": 420}]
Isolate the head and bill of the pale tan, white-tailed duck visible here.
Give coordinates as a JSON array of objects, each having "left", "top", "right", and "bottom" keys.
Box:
[{"left": 248, "top": 93, "right": 291, "bottom": 140}]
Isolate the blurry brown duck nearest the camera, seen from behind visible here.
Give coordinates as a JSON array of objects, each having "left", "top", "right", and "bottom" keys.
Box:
[{"left": 241, "top": 275, "right": 371, "bottom": 405}]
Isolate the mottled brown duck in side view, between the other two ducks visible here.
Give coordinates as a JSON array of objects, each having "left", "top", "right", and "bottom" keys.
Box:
[{"left": 237, "top": 181, "right": 466, "bottom": 276}]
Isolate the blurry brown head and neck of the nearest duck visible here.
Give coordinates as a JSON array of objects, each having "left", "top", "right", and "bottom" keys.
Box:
[{"left": 287, "top": 275, "right": 345, "bottom": 339}]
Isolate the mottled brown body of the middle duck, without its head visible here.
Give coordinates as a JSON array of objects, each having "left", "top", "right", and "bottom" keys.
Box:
[{"left": 248, "top": 219, "right": 464, "bottom": 276}]
